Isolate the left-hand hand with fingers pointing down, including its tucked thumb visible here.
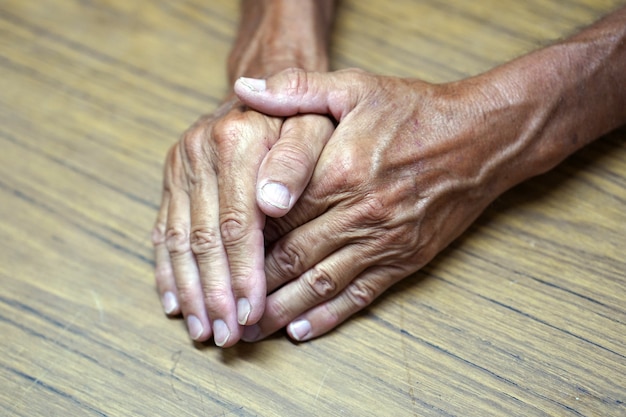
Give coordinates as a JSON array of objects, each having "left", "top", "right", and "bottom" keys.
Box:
[{"left": 153, "top": 96, "right": 333, "bottom": 347}]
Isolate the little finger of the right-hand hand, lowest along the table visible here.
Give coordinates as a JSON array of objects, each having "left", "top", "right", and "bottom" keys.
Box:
[{"left": 287, "top": 267, "right": 406, "bottom": 342}]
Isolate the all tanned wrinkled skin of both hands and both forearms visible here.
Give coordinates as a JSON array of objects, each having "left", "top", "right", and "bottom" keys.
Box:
[{"left": 153, "top": 5, "right": 626, "bottom": 346}]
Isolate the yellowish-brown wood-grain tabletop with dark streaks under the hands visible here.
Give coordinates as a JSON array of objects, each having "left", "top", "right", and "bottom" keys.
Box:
[{"left": 0, "top": 0, "right": 626, "bottom": 416}]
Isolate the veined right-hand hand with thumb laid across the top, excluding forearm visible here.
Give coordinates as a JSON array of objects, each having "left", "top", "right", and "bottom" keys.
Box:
[{"left": 235, "top": 70, "right": 519, "bottom": 341}]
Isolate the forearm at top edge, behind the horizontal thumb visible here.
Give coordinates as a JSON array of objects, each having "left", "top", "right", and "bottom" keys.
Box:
[{"left": 228, "top": 0, "right": 334, "bottom": 85}]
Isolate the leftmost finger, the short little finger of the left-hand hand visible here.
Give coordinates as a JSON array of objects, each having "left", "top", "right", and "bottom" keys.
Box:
[{"left": 152, "top": 188, "right": 180, "bottom": 316}]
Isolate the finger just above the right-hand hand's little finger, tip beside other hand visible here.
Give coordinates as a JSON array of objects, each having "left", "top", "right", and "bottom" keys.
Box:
[{"left": 243, "top": 246, "right": 370, "bottom": 341}]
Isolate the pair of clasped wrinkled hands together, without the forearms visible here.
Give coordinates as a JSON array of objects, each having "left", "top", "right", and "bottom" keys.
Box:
[{"left": 154, "top": 70, "right": 498, "bottom": 346}]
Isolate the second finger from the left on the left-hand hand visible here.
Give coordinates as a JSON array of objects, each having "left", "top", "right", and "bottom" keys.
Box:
[{"left": 165, "top": 179, "right": 211, "bottom": 341}]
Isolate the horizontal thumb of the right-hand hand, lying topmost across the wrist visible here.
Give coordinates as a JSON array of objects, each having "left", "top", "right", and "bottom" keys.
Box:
[{"left": 234, "top": 68, "right": 371, "bottom": 121}]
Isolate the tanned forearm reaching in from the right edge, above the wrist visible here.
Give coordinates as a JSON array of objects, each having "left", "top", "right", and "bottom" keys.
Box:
[{"left": 477, "top": 8, "right": 626, "bottom": 189}]
